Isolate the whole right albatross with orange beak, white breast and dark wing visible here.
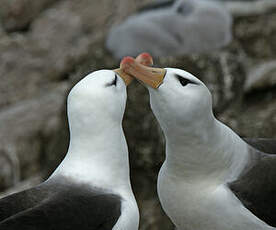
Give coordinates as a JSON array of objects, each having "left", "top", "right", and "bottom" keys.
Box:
[{"left": 123, "top": 59, "right": 276, "bottom": 230}]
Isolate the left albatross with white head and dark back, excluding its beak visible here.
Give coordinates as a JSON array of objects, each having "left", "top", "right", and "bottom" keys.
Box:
[{"left": 0, "top": 70, "right": 139, "bottom": 230}]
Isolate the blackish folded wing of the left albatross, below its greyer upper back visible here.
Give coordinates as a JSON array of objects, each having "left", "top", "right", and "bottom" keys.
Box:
[{"left": 0, "top": 183, "right": 121, "bottom": 230}]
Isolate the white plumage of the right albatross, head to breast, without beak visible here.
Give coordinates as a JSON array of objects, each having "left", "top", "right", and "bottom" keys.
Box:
[{"left": 149, "top": 68, "right": 275, "bottom": 230}]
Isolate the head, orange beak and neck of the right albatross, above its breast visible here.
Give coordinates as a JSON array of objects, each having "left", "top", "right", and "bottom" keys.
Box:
[{"left": 122, "top": 57, "right": 248, "bottom": 184}]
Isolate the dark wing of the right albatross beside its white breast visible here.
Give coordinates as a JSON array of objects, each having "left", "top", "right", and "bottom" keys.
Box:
[{"left": 228, "top": 151, "right": 276, "bottom": 227}]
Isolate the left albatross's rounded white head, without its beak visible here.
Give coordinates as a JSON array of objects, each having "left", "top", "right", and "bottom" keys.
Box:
[{"left": 67, "top": 70, "right": 127, "bottom": 135}]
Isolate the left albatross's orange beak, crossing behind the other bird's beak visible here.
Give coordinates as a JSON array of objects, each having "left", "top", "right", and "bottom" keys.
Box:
[{"left": 113, "top": 53, "right": 153, "bottom": 86}]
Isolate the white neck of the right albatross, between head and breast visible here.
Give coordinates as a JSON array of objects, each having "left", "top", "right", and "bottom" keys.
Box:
[{"left": 164, "top": 118, "right": 248, "bottom": 184}]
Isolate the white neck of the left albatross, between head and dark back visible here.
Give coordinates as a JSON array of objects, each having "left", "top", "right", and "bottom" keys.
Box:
[{"left": 52, "top": 123, "right": 131, "bottom": 190}]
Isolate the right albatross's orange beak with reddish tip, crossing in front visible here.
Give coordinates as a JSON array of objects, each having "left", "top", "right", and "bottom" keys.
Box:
[{"left": 120, "top": 57, "right": 166, "bottom": 89}]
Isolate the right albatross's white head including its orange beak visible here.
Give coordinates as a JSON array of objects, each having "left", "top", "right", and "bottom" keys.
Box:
[{"left": 122, "top": 58, "right": 214, "bottom": 136}]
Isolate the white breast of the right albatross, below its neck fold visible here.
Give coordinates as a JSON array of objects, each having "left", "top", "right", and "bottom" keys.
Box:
[{"left": 158, "top": 165, "right": 275, "bottom": 230}]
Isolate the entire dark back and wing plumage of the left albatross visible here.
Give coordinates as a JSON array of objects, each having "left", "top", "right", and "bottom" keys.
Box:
[{"left": 0, "top": 177, "right": 121, "bottom": 230}]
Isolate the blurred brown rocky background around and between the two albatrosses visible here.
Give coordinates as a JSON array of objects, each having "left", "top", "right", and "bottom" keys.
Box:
[{"left": 0, "top": 0, "right": 276, "bottom": 230}]
